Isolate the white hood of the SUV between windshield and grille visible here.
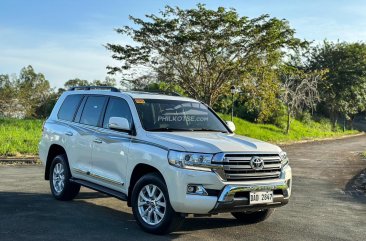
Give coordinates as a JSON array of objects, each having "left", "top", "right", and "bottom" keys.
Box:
[{"left": 147, "top": 132, "right": 281, "bottom": 153}]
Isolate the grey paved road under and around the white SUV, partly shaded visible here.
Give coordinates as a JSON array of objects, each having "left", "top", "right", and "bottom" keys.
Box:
[{"left": 0, "top": 136, "right": 366, "bottom": 241}]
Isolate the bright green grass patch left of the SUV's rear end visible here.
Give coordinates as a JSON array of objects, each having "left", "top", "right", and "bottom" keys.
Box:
[{"left": 0, "top": 119, "right": 43, "bottom": 156}]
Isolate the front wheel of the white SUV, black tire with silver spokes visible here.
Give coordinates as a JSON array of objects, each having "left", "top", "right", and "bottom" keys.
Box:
[{"left": 131, "top": 173, "right": 184, "bottom": 234}]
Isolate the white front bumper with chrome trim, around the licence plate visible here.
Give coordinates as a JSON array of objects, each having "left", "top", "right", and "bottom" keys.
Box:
[{"left": 167, "top": 165, "right": 292, "bottom": 214}]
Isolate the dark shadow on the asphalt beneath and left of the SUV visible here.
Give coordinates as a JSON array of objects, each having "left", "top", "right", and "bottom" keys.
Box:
[{"left": 0, "top": 192, "right": 249, "bottom": 241}]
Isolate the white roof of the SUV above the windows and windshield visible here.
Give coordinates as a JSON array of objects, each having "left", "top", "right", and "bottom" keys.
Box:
[{"left": 65, "top": 90, "right": 199, "bottom": 102}]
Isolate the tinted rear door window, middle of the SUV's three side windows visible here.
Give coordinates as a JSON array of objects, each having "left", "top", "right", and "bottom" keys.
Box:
[{"left": 80, "top": 96, "right": 106, "bottom": 126}]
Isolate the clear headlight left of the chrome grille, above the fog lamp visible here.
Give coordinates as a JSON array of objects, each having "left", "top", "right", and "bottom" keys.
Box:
[{"left": 168, "top": 151, "right": 213, "bottom": 171}]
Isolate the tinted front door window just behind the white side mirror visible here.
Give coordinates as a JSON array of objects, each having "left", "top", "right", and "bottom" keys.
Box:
[{"left": 103, "top": 98, "right": 132, "bottom": 128}]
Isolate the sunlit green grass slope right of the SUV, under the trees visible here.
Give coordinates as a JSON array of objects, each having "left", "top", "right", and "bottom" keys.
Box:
[{"left": 220, "top": 115, "right": 358, "bottom": 144}]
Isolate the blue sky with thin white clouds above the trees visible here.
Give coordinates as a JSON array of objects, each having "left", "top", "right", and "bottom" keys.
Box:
[{"left": 0, "top": 0, "right": 366, "bottom": 88}]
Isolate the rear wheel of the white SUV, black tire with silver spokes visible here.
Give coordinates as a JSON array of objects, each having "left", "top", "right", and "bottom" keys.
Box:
[{"left": 49, "top": 154, "right": 80, "bottom": 201}]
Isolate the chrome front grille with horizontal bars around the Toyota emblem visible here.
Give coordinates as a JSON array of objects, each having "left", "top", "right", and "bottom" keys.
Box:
[{"left": 216, "top": 153, "right": 281, "bottom": 181}]
